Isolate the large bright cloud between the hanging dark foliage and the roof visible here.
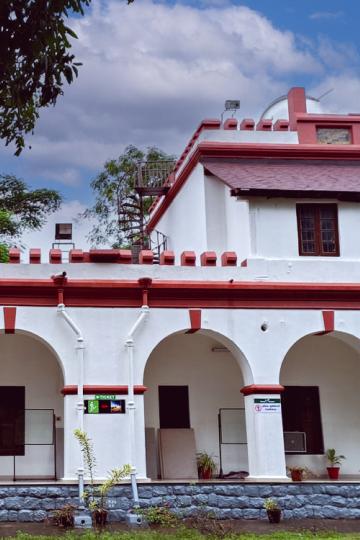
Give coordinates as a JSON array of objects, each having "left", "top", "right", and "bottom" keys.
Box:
[{"left": 0, "top": 0, "right": 321, "bottom": 181}]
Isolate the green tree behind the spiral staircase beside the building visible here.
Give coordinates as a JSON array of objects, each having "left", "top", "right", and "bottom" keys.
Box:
[{"left": 83, "top": 145, "right": 174, "bottom": 247}]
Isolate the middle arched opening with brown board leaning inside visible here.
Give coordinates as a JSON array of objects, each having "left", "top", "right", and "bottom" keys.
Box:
[{"left": 144, "top": 331, "right": 248, "bottom": 479}]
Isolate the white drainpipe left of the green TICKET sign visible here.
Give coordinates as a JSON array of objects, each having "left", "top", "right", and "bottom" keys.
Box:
[{"left": 57, "top": 304, "right": 85, "bottom": 503}]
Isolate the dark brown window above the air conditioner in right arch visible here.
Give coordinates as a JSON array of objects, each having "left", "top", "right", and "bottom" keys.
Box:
[{"left": 281, "top": 386, "right": 324, "bottom": 454}]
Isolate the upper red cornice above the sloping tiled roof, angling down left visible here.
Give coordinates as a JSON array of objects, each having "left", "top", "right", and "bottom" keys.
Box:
[{"left": 147, "top": 141, "right": 360, "bottom": 232}]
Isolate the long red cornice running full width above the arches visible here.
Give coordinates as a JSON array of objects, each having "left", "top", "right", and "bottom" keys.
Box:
[{"left": 0, "top": 279, "right": 360, "bottom": 310}]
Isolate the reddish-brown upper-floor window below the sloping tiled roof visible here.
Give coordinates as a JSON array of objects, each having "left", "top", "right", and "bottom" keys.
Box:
[{"left": 296, "top": 204, "right": 340, "bottom": 257}]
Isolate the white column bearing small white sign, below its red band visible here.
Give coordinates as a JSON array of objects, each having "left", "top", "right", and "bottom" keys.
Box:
[{"left": 244, "top": 394, "right": 287, "bottom": 480}]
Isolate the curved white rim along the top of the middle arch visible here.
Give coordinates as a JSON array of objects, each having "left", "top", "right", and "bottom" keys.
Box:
[{"left": 142, "top": 328, "right": 254, "bottom": 386}]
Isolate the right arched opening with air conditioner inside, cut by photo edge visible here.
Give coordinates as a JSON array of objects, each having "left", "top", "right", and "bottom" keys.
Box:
[{"left": 280, "top": 332, "right": 360, "bottom": 477}]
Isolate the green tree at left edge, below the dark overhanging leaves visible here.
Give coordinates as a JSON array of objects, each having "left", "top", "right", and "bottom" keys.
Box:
[{"left": 0, "top": 175, "right": 61, "bottom": 244}]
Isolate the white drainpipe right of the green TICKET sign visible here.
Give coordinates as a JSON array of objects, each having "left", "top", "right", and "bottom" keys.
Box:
[{"left": 125, "top": 305, "right": 149, "bottom": 507}]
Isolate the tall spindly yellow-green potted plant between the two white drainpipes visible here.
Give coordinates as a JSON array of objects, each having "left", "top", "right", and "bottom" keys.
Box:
[{"left": 74, "top": 429, "right": 131, "bottom": 527}]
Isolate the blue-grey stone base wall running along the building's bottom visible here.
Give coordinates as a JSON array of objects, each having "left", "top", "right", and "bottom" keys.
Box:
[{"left": 0, "top": 482, "right": 360, "bottom": 522}]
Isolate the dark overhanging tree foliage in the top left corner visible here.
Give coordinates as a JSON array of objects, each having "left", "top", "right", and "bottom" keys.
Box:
[{"left": 0, "top": 0, "right": 91, "bottom": 155}]
